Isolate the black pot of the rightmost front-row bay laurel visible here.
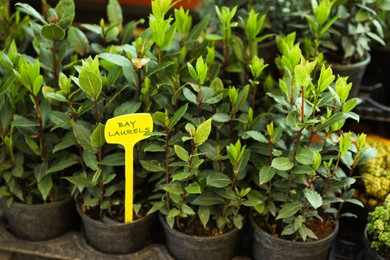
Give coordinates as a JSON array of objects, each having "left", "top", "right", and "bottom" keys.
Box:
[{"left": 249, "top": 214, "right": 339, "bottom": 260}]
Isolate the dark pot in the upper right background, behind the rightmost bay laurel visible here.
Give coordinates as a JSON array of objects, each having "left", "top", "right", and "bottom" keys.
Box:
[{"left": 332, "top": 53, "right": 371, "bottom": 98}]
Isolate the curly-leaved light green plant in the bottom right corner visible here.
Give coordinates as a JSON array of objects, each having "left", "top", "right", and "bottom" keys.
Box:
[{"left": 364, "top": 195, "right": 390, "bottom": 260}]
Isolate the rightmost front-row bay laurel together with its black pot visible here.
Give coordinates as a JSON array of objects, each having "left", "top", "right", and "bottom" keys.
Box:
[{"left": 249, "top": 34, "right": 378, "bottom": 259}]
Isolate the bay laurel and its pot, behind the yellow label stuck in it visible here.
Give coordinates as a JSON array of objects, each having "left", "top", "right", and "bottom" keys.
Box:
[{"left": 56, "top": 0, "right": 158, "bottom": 254}]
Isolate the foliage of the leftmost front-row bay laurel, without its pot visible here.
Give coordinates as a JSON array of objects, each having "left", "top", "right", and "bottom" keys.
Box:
[{"left": 1, "top": 43, "right": 78, "bottom": 204}]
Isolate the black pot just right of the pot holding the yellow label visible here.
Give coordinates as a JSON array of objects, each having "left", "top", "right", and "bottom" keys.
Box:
[{"left": 159, "top": 214, "right": 239, "bottom": 260}]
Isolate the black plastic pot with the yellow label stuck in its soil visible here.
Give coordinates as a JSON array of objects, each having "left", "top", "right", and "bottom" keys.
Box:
[{"left": 77, "top": 203, "right": 156, "bottom": 254}]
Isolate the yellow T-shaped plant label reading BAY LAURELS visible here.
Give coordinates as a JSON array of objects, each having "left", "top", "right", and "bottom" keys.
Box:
[{"left": 104, "top": 113, "right": 153, "bottom": 223}]
